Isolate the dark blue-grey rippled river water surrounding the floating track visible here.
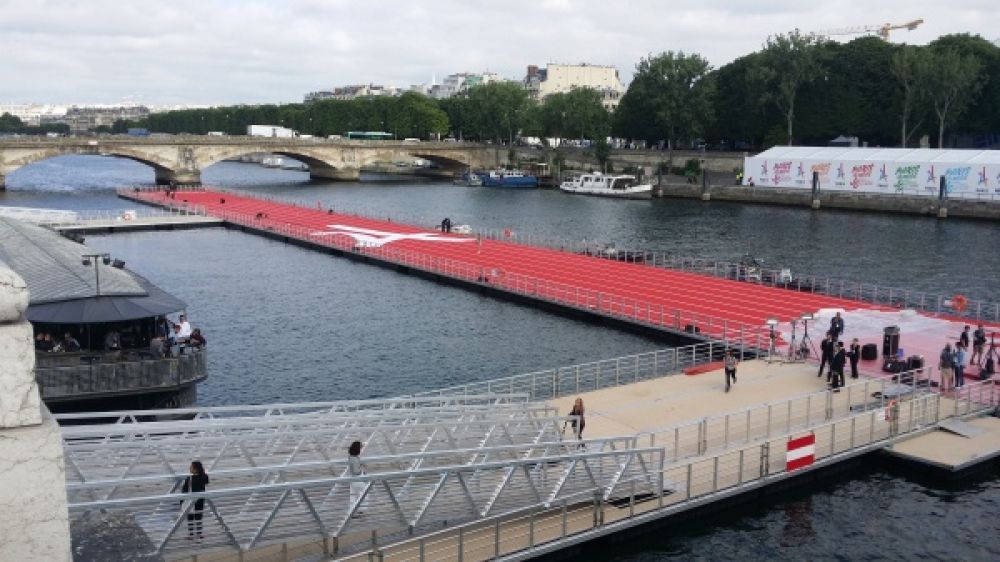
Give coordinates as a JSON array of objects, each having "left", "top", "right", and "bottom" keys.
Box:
[{"left": 0, "top": 156, "right": 1000, "bottom": 561}]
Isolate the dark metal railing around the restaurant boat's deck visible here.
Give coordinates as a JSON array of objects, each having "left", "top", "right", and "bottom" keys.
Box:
[{"left": 35, "top": 349, "right": 208, "bottom": 402}]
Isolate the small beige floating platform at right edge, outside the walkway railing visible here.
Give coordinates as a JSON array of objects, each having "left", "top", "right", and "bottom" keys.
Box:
[{"left": 886, "top": 416, "right": 1000, "bottom": 472}]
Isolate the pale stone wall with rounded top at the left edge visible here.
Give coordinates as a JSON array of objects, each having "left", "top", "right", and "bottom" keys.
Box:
[{"left": 0, "top": 266, "right": 71, "bottom": 562}]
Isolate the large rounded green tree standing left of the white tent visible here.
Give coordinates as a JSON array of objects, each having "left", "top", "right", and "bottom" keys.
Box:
[{"left": 622, "top": 51, "right": 715, "bottom": 161}]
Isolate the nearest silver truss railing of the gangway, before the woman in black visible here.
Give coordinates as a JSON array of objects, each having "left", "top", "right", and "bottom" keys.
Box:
[{"left": 69, "top": 442, "right": 663, "bottom": 558}]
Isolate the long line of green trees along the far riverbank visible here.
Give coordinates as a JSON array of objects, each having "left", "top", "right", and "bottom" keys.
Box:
[{"left": 103, "top": 31, "right": 1000, "bottom": 150}]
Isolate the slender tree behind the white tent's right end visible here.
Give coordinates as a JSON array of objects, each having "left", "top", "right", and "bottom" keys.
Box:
[{"left": 916, "top": 47, "right": 983, "bottom": 148}]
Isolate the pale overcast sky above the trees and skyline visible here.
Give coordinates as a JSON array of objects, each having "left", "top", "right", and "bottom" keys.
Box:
[{"left": 0, "top": 0, "right": 1000, "bottom": 105}]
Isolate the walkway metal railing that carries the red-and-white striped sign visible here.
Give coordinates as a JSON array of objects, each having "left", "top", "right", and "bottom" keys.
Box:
[{"left": 362, "top": 393, "right": 941, "bottom": 562}]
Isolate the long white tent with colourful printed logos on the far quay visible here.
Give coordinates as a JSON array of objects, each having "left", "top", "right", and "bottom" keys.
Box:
[{"left": 743, "top": 146, "right": 1000, "bottom": 197}]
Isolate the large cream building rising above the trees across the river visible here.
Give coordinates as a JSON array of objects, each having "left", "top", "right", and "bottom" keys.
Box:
[{"left": 524, "top": 63, "right": 625, "bottom": 111}]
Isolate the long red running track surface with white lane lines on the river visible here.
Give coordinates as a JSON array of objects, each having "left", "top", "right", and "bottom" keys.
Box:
[{"left": 126, "top": 191, "right": 896, "bottom": 344}]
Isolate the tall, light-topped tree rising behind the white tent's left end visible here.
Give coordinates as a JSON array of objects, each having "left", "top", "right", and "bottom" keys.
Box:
[{"left": 755, "top": 30, "right": 820, "bottom": 145}]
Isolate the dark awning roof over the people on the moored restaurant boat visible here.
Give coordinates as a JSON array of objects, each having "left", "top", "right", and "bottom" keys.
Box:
[{"left": 26, "top": 273, "right": 187, "bottom": 324}]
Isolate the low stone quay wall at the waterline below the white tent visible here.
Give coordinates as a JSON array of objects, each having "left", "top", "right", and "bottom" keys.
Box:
[{"left": 657, "top": 184, "right": 1000, "bottom": 220}]
